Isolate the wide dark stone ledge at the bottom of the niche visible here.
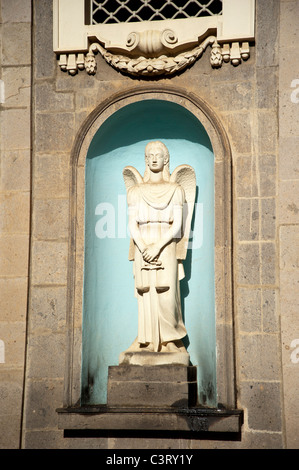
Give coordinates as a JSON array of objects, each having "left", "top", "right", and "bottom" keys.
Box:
[{"left": 56, "top": 405, "right": 243, "bottom": 433}]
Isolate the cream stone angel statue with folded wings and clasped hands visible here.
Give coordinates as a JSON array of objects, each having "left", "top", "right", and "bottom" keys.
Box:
[{"left": 123, "top": 141, "right": 196, "bottom": 352}]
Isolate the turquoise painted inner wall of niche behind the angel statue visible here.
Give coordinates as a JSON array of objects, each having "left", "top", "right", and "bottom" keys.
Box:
[{"left": 81, "top": 100, "right": 217, "bottom": 407}]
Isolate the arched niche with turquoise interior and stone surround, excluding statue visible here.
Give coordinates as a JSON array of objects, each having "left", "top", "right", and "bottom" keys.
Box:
[{"left": 65, "top": 88, "right": 235, "bottom": 408}]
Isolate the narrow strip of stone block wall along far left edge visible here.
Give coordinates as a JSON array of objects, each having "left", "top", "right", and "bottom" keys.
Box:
[{"left": 0, "top": 0, "right": 31, "bottom": 449}]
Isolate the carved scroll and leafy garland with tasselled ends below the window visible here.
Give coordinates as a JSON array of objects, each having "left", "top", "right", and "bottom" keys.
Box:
[{"left": 59, "top": 29, "right": 249, "bottom": 77}]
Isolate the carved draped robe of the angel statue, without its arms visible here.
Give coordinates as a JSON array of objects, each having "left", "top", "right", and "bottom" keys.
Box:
[{"left": 128, "top": 181, "right": 187, "bottom": 351}]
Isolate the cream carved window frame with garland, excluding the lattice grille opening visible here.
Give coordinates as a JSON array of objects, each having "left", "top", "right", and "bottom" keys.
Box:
[{"left": 53, "top": 0, "right": 255, "bottom": 76}]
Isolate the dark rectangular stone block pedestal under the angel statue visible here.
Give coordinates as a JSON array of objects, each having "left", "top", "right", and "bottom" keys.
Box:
[{"left": 107, "top": 364, "right": 197, "bottom": 408}]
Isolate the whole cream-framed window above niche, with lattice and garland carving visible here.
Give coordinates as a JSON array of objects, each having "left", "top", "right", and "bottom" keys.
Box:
[{"left": 53, "top": 0, "right": 255, "bottom": 77}]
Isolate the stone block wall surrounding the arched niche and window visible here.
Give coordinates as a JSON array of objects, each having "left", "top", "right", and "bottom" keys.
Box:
[{"left": 0, "top": 0, "right": 299, "bottom": 449}]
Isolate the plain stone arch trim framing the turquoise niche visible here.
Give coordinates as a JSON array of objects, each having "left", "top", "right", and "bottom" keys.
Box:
[{"left": 64, "top": 86, "right": 236, "bottom": 409}]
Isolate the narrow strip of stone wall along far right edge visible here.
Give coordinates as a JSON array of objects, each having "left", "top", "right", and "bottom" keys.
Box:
[{"left": 277, "top": 1, "right": 299, "bottom": 449}]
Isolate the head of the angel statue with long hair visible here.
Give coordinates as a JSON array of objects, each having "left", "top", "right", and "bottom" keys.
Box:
[{"left": 143, "top": 140, "right": 170, "bottom": 182}]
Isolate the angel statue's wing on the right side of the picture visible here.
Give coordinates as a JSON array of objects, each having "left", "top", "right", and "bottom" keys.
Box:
[{"left": 170, "top": 165, "right": 196, "bottom": 259}]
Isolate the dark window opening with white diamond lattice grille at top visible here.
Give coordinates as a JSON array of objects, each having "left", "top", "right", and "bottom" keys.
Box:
[{"left": 91, "top": 0, "right": 222, "bottom": 24}]
